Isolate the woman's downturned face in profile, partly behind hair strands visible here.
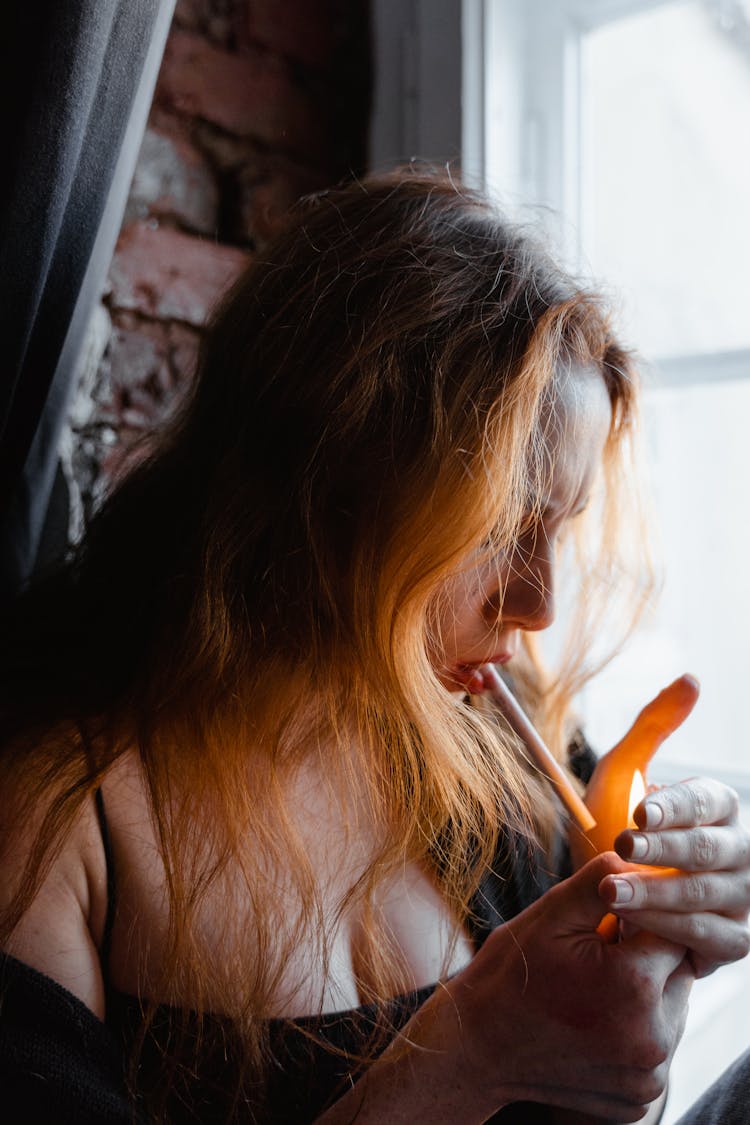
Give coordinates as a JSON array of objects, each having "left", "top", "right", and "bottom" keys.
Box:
[{"left": 432, "top": 368, "right": 612, "bottom": 691}]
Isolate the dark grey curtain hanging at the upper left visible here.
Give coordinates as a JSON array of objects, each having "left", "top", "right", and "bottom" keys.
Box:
[{"left": 0, "top": 0, "right": 174, "bottom": 602}]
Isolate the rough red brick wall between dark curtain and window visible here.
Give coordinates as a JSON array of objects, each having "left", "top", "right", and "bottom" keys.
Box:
[{"left": 69, "top": 0, "right": 370, "bottom": 531}]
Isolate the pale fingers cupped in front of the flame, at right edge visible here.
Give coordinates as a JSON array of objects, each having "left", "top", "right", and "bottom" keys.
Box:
[{"left": 599, "top": 777, "right": 750, "bottom": 977}]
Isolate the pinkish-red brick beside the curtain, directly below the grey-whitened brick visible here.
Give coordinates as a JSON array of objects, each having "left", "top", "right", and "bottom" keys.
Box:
[{"left": 109, "top": 222, "right": 249, "bottom": 327}]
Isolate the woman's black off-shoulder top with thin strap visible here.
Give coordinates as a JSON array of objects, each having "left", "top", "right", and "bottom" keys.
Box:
[{"left": 0, "top": 752, "right": 594, "bottom": 1125}]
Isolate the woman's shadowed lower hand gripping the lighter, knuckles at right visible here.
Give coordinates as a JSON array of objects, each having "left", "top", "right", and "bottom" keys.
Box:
[{"left": 446, "top": 853, "right": 694, "bottom": 1122}]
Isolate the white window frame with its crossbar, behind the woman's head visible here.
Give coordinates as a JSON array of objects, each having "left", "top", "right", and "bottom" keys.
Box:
[{"left": 481, "top": 0, "right": 750, "bottom": 387}]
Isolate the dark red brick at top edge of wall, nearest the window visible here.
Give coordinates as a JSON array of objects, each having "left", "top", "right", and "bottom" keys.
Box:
[{"left": 245, "top": 0, "right": 342, "bottom": 70}]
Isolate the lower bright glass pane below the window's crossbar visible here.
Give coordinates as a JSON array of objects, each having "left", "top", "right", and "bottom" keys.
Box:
[{"left": 585, "top": 371, "right": 750, "bottom": 780}]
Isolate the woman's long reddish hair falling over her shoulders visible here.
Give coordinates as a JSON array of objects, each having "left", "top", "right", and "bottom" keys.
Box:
[{"left": 0, "top": 170, "right": 645, "bottom": 1116}]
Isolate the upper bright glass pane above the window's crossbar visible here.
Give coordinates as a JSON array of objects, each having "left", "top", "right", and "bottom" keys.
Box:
[{"left": 581, "top": 0, "right": 750, "bottom": 356}]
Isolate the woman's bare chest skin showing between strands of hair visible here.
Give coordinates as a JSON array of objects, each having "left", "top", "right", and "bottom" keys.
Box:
[{"left": 105, "top": 767, "right": 472, "bottom": 1017}]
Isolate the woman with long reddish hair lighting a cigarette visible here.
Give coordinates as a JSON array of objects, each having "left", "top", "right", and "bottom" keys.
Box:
[{"left": 0, "top": 172, "right": 750, "bottom": 1123}]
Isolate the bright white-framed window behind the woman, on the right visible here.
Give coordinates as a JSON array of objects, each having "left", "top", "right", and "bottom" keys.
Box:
[{"left": 474, "top": 0, "right": 750, "bottom": 1111}]
